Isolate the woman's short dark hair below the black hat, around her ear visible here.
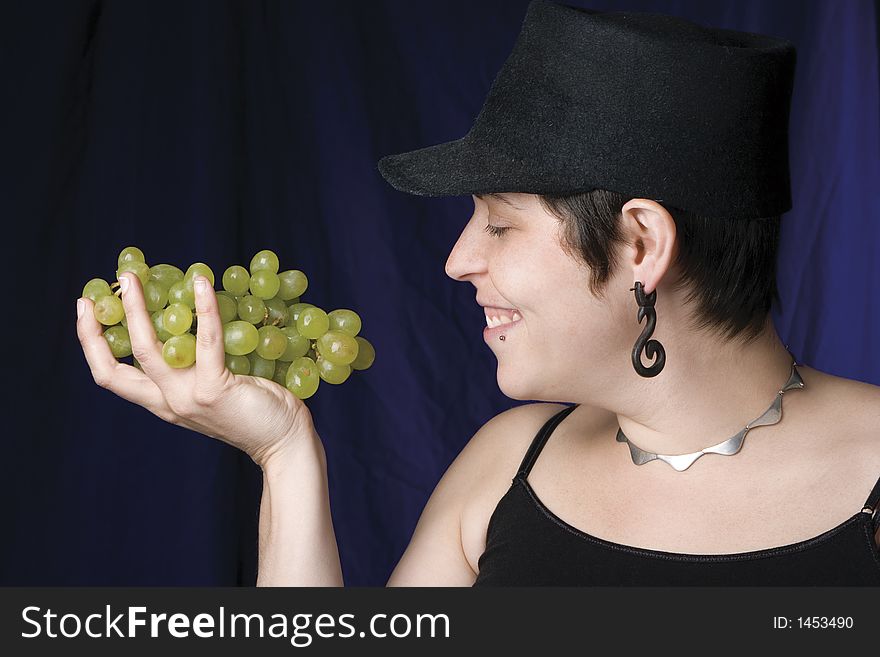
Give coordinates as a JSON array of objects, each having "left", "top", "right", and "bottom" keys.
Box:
[{"left": 540, "top": 189, "right": 781, "bottom": 344}]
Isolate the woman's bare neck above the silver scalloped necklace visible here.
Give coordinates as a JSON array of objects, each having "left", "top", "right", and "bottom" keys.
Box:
[{"left": 608, "top": 320, "right": 792, "bottom": 454}]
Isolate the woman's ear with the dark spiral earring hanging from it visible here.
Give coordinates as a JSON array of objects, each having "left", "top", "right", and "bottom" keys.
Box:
[{"left": 621, "top": 198, "right": 678, "bottom": 294}]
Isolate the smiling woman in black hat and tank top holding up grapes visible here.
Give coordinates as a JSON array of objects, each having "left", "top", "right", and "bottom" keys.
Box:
[{"left": 77, "top": 2, "right": 880, "bottom": 585}]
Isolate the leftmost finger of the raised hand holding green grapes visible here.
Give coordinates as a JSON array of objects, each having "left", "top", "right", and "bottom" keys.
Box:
[{"left": 76, "top": 299, "right": 172, "bottom": 414}]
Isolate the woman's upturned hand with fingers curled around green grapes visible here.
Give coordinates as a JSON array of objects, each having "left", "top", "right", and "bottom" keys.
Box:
[{"left": 76, "top": 273, "right": 314, "bottom": 469}]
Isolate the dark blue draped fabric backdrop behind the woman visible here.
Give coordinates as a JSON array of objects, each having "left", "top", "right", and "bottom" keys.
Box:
[{"left": 0, "top": 0, "right": 880, "bottom": 585}]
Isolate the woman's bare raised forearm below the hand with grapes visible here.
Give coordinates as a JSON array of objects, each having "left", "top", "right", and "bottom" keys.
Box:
[{"left": 257, "top": 433, "right": 343, "bottom": 586}]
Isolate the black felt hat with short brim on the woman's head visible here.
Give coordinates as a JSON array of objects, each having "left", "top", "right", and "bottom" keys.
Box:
[{"left": 379, "top": 0, "right": 795, "bottom": 219}]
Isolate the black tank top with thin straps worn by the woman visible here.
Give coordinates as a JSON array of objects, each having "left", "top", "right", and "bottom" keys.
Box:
[{"left": 474, "top": 405, "right": 880, "bottom": 586}]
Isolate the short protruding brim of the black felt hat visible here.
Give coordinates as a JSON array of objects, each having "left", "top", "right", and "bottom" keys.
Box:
[{"left": 378, "top": 137, "right": 498, "bottom": 196}]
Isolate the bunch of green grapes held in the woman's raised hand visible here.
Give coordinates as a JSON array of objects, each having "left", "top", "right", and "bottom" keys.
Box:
[{"left": 82, "top": 246, "right": 376, "bottom": 399}]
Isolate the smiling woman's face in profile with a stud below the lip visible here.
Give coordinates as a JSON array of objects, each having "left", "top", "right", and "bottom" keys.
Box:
[{"left": 446, "top": 193, "right": 635, "bottom": 401}]
